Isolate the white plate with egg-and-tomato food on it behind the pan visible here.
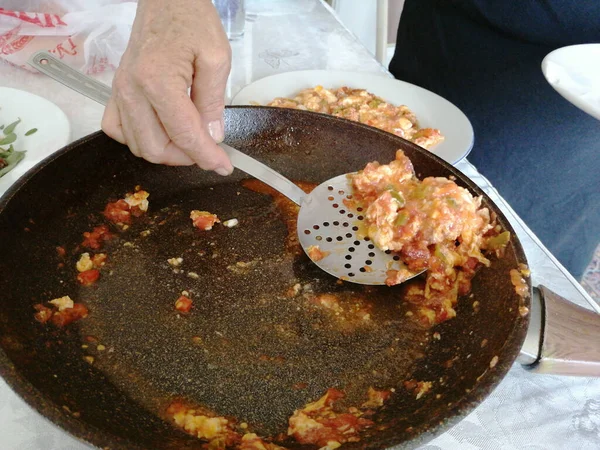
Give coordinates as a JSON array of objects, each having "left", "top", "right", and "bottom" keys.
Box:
[{"left": 231, "top": 70, "right": 474, "bottom": 164}]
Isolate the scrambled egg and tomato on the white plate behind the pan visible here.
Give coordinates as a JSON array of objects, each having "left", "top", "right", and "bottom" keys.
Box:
[{"left": 267, "top": 86, "right": 444, "bottom": 149}]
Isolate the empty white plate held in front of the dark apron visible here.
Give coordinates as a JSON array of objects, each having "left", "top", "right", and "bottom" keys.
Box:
[{"left": 542, "top": 44, "right": 600, "bottom": 119}]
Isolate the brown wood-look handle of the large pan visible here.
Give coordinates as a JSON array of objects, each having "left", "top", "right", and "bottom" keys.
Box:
[{"left": 520, "top": 285, "right": 600, "bottom": 377}]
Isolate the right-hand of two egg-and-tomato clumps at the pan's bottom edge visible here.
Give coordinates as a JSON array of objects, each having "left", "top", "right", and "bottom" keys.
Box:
[{"left": 288, "top": 388, "right": 374, "bottom": 449}]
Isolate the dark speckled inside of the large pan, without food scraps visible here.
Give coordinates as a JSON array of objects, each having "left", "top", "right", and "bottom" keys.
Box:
[{"left": 0, "top": 107, "right": 527, "bottom": 449}]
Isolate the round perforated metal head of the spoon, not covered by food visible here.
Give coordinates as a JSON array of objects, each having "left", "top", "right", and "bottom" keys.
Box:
[{"left": 298, "top": 175, "right": 422, "bottom": 285}]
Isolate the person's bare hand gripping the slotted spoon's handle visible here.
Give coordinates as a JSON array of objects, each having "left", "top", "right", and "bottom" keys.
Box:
[{"left": 102, "top": 0, "right": 233, "bottom": 175}]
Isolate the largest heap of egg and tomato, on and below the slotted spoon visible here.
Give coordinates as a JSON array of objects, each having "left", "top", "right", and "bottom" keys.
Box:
[{"left": 350, "top": 150, "right": 510, "bottom": 325}]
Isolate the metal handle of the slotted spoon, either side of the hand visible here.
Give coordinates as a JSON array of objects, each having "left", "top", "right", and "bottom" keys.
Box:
[{"left": 28, "top": 51, "right": 306, "bottom": 205}]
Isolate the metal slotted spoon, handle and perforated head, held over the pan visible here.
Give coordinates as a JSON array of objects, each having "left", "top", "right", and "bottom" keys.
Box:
[{"left": 28, "top": 51, "right": 420, "bottom": 285}]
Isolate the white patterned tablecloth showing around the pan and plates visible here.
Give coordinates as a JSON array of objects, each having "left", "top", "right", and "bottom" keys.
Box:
[{"left": 0, "top": 0, "right": 600, "bottom": 450}]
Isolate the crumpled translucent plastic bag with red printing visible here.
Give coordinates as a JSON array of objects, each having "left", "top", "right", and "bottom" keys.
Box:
[{"left": 0, "top": 0, "right": 137, "bottom": 74}]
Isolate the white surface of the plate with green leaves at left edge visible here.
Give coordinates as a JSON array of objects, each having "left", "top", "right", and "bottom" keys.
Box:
[{"left": 0, "top": 87, "right": 71, "bottom": 197}]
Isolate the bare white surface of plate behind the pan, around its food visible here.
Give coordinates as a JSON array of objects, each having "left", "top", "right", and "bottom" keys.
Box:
[{"left": 231, "top": 70, "right": 473, "bottom": 164}]
